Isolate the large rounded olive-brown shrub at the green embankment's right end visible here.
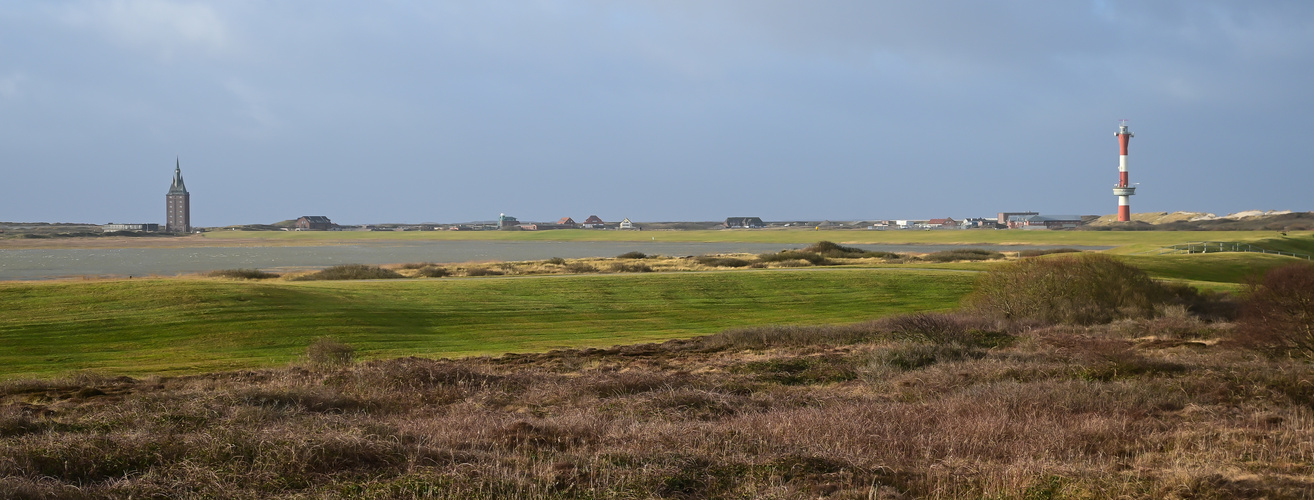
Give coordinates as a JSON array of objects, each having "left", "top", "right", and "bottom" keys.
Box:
[{"left": 966, "top": 253, "right": 1171, "bottom": 324}]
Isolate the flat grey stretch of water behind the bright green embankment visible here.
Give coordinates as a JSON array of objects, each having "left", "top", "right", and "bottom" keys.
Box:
[{"left": 0, "top": 241, "right": 1108, "bottom": 280}]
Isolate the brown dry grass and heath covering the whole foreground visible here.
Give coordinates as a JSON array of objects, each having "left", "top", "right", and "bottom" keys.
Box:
[{"left": 0, "top": 311, "right": 1314, "bottom": 499}]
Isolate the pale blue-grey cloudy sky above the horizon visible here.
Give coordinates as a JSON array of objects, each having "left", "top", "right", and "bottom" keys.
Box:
[{"left": 0, "top": 0, "right": 1314, "bottom": 226}]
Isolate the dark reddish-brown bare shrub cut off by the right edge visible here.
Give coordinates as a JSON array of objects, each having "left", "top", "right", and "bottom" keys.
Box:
[{"left": 1238, "top": 264, "right": 1314, "bottom": 357}]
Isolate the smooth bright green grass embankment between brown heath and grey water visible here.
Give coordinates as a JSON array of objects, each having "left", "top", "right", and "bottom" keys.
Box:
[{"left": 0, "top": 269, "right": 974, "bottom": 378}]
